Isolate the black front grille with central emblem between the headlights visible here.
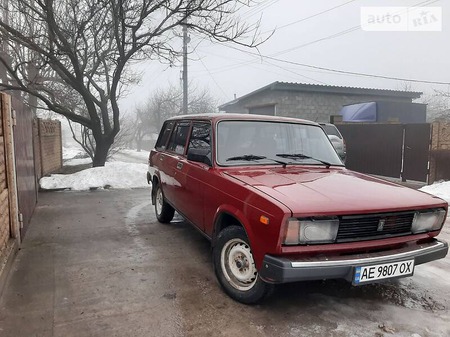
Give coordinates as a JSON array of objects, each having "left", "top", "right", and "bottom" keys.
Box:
[{"left": 336, "top": 212, "right": 414, "bottom": 242}]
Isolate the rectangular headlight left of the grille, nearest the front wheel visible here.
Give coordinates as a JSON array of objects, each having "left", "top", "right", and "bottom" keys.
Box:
[{"left": 284, "top": 219, "right": 339, "bottom": 245}]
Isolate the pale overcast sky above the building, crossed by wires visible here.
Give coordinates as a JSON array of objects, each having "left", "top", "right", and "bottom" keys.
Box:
[{"left": 121, "top": 0, "right": 450, "bottom": 111}]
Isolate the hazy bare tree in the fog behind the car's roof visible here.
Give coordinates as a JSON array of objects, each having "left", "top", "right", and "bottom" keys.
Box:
[{"left": 134, "top": 85, "right": 217, "bottom": 151}]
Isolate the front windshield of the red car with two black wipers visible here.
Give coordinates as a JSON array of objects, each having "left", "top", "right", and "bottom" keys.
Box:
[{"left": 216, "top": 121, "right": 343, "bottom": 166}]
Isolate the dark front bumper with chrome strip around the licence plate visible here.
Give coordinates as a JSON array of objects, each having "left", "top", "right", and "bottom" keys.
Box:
[{"left": 259, "top": 240, "right": 448, "bottom": 283}]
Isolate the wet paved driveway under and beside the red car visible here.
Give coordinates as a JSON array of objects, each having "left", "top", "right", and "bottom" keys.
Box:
[{"left": 0, "top": 189, "right": 450, "bottom": 337}]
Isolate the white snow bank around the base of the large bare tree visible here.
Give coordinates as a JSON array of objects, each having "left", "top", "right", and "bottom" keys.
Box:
[{"left": 39, "top": 148, "right": 148, "bottom": 191}]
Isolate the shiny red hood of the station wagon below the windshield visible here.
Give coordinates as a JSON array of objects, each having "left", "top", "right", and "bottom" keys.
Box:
[{"left": 225, "top": 166, "right": 446, "bottom": 216}]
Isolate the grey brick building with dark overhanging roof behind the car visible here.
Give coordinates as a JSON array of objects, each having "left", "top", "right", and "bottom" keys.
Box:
[{"left": 219, "top": 82, "right": 422, "bottom": 122}]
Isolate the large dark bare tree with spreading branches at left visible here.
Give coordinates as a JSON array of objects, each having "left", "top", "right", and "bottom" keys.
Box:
[{"left": 0, "top": 0, "right": 262, "bottom": 166}]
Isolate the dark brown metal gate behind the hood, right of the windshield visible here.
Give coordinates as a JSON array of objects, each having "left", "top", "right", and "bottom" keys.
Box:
[{"left": 336, "top": 123, "right": 430, "bottom": 182}]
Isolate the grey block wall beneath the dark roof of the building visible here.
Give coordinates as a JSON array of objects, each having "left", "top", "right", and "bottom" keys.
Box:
[{"left": 227, "top": 90, "right": 411, "bottom": 122}]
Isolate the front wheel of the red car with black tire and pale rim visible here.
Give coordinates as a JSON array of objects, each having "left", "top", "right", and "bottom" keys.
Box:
[{"left": 213, "top": 226, "right": 274, "bottom": 304}]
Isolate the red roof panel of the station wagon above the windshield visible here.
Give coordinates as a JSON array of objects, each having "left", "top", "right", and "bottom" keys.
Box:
[{"left": 168, "top": 113, "right": 318, "bottom": 125}]
